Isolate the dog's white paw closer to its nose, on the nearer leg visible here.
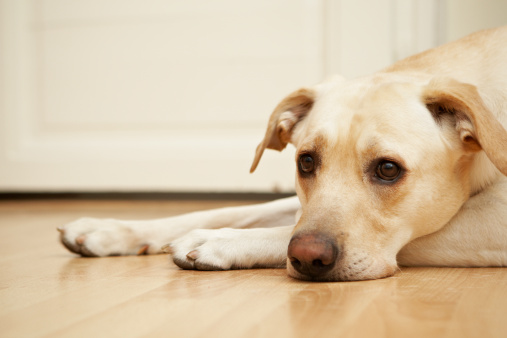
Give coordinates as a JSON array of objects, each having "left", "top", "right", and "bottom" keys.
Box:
[{"left": 166, "top": 228, "right": 243, "bottom": 270}]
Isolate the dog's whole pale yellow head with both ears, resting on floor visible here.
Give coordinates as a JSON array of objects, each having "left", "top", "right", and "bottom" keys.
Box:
[{"left": 252, "top": 74, "right": 507, "bottom": 281}]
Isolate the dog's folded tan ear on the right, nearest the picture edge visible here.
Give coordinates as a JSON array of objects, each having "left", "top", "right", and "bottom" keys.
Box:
[{"left": 423, "top": 78, "right": 507, "bottom": 175}]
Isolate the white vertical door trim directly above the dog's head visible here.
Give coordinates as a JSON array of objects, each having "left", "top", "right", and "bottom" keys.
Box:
[{"left": 323, "top": 0, "right": 445, "bottom": 78}]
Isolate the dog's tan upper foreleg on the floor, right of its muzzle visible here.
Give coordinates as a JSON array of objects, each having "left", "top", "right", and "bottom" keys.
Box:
[{"left": 398, "top": 178, "right": 507, "bottom": 267}]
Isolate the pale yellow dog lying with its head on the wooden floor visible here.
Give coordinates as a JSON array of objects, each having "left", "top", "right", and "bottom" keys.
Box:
[{"left": 58, "top": 27, "right": 507, "bottom": 281}]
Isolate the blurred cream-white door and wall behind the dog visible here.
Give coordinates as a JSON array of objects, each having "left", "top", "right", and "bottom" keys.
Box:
[{"left": 0, "top": 0, "right": 507, "bottom": 193}]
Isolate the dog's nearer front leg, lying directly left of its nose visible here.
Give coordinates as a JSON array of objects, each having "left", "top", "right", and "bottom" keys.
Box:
[{"left": 168, "top": 226, "right": 294, "bottom": 270}]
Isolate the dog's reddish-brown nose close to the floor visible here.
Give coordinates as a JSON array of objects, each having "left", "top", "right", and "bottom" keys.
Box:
[{"left": 287, "top": 233, "right": 338, "bottom": 277}]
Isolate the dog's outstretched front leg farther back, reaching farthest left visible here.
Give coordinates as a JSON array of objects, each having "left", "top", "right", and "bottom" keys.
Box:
[{"left": 58, "top": 197, "right": 299, "bottom": 257}]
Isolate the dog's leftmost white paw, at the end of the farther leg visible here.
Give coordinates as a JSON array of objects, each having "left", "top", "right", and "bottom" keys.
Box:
[{"left": 58, "top": 218, "right": 150, "bottom": 257}]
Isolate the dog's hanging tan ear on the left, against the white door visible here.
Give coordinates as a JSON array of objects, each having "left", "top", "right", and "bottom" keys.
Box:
[{"left": 250, "top": 88, "right": 315, "bottom": 173}]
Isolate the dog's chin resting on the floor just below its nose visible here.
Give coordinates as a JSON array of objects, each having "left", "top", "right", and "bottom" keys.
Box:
[{"left": 287, "top": 261, "right": 398, "bottom": 282}]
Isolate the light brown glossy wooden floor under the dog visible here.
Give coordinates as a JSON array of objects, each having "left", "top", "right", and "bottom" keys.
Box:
[{"left": 0, "top": 201, "right": 507, "bottom": 338}]
